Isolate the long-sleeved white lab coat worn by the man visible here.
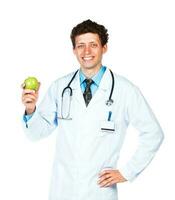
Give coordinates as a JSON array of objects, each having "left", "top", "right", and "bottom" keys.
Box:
[{"left": 24, "top": 69, "right": 163, "bottom": 200}]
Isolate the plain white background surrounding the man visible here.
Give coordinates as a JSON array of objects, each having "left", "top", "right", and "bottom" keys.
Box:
[{"left": 0, "top": 0, "right": 175, "bottom": 200}]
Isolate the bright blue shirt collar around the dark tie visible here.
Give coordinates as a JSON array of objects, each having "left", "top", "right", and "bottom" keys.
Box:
[{"left": 79, "top": 66, "right": 106, "bottom": 86}]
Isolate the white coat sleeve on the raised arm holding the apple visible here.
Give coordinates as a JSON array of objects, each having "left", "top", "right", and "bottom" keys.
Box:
[{"left": 22, "top": 83, "right": 57, "bottom": 141}]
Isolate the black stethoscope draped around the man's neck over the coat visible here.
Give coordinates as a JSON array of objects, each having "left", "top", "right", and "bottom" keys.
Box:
[{"left": 59, "top": 70, "right": 115, "bottom": 120}]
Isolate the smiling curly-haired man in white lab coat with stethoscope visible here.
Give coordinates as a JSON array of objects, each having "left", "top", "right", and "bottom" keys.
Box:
[{"left": 22, "top": 20, "right": 164, "bottom": 200}]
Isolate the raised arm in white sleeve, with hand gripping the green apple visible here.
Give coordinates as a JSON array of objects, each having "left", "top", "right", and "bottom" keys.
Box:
[{"left": 22, "top": 81, "right": 57, "bottom": 140}]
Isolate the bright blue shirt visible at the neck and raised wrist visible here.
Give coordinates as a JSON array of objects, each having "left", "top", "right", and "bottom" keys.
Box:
[{"left": 23, "top": 66, "right": 106, "bottom": 122}]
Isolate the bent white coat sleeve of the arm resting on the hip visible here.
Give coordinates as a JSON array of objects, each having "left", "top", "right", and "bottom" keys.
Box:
[{"left": 119, "top": 86, "right": 164, "bottom": 181}]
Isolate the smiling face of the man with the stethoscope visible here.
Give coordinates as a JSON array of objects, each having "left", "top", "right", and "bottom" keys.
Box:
[{"left": 73, "top": 33, "right": 107, "bottom": 71}]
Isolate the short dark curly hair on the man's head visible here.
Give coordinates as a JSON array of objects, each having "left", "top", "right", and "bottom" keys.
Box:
[{"left": 70, "top": 19, "right": 108, "bottom": 48}]
